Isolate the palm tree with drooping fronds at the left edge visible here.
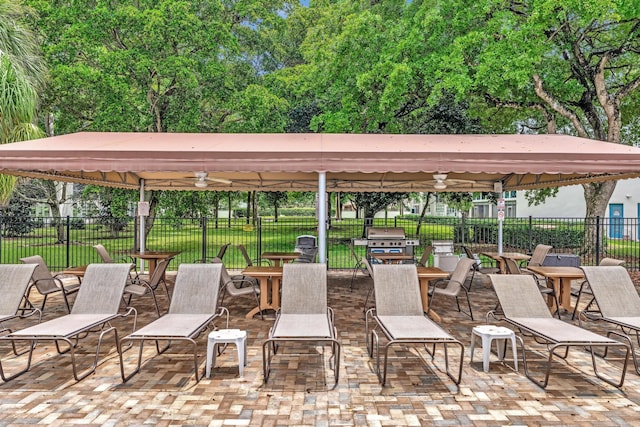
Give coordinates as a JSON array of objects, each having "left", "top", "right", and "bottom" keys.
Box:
[{"left": 0, "top": 0, "right": 47, "bottom": 206}]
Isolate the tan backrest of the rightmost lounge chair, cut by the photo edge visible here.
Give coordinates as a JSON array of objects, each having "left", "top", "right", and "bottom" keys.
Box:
[{"left": 582, "top": 266, "right": 640, "bottom": 317}]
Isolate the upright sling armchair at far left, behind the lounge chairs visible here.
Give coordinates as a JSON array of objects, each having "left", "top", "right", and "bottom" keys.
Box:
[{"left": 20, "top": 255, "right": 80, "bottom": 313}]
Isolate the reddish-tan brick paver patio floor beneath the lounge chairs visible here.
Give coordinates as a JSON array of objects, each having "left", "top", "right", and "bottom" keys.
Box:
[{"left": 0, "top": 272, "right": 640, "bottom": 426}]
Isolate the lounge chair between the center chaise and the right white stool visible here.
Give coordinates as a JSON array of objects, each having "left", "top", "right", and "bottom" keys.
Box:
[{"left": 365, "top": 264, "right": 464, "bottom": 386}]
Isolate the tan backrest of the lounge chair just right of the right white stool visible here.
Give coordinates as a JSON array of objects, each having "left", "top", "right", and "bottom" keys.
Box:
[{"left": 489, "top": 274, "right": 552, "bottom": 319}]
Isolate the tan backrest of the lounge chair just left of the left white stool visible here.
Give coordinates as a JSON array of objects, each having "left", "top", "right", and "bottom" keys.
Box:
[{"left": 169, "top": 263, "right": 222, "bottom": 314}]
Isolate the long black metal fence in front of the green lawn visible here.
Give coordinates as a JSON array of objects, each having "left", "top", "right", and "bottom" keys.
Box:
[{"left": 0, "top": 217, "right": 640, "bottom": 270}]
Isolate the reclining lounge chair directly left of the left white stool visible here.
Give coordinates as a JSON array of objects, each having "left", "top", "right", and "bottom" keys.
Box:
[{"left": 119, "top": 263, "right": 229, "bottom": 382}]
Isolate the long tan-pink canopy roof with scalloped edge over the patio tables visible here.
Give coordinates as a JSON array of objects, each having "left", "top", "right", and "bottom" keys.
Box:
[{"left": 0, "top": 132, "right": 640, "bottom": 192}]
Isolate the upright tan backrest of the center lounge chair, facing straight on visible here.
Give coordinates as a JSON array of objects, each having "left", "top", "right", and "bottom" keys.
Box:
[{"left": 280, "top": 263, "right": 328, "bottom": 314}]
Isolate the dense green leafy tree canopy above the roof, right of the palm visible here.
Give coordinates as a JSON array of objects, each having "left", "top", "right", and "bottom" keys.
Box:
[{"left": 0, "top": 0, "right": 640, "bottom": 216}]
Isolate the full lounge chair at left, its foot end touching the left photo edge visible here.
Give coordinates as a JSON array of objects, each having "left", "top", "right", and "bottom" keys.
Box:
[{"left": 0, "top": 264, "right": 137, "bottom": 381}]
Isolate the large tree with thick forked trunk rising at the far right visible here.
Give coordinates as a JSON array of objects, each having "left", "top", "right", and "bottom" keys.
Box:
[{"left": 421, "top": 0, "right": 640, "bottom": 254}]
